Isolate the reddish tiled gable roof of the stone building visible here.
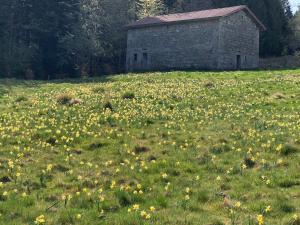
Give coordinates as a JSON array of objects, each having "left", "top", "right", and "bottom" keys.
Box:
[{"left": 126, "top": 5, "right": 266, "bottom": 30}]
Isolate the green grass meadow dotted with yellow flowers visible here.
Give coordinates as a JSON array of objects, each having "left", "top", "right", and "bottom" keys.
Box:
[{"left": 0, "top": 70, "right": 300, "bottom": 225}]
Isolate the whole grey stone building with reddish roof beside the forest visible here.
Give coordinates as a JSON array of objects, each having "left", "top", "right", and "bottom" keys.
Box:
[{"left": 126, "top": 6, "right": 265, "bottom": 71}]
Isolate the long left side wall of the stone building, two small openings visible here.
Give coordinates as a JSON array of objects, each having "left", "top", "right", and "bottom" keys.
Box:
[{"left": 126, "top": 20, "right": 219, "bottom": 71}]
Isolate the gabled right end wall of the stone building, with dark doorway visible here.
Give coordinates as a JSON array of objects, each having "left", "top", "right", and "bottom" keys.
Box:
[{"left": 218, "top": 11, "right": 259, "bottom": 69}]
